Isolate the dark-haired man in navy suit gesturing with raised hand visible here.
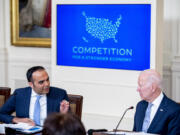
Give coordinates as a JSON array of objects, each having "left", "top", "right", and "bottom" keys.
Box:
[{"left": 0, "top": 66, "right": 69, "bottom": 125}]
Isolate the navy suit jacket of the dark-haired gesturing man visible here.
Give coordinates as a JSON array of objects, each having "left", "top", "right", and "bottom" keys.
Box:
[{"left": 0, "top": 87, "right": 69, "bottom": 123}]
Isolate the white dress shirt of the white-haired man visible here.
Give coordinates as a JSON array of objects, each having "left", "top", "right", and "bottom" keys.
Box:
[{"left": 150, "top": 92, "right": 164, "bottom": 124}]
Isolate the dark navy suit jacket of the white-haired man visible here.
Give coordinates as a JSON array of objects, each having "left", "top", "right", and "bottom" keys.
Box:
[{"left": 133, "top": 95, "right": 180, "bottom": 135}]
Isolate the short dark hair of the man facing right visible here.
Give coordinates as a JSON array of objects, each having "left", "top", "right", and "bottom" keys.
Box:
[{"left": 26, "top": 66, "right": 45, "bottom": 82}]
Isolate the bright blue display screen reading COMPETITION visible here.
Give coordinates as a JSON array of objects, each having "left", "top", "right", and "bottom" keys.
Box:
[{"left": 57, "top": 4, "right": 151, "bottom": 70}]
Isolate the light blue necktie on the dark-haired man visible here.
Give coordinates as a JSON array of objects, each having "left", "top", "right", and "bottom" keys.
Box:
[{"left": 33, "top": 95, "right": 41, "bottom": 125}]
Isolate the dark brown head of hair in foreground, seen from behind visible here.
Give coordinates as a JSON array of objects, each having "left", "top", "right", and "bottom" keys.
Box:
[{"left": 42, "top": 113, "right": 86, "bottom": 135}]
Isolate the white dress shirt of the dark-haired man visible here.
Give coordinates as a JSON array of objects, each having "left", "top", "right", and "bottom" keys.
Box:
[{"left": 29, "top": 89, "right": 47, "bottom": 126}]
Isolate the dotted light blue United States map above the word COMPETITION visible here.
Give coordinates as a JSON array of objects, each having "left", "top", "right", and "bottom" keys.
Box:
[{"left": 82, "top": 11, "right": 122, "bottom": 43}]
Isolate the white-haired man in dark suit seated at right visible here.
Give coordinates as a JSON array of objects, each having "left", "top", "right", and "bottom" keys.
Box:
[{"left": 133, "top": 70, "right": 180, "bottom": 135}]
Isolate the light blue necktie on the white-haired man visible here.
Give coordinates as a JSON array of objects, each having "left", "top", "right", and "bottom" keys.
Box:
[{"left": 142, "top": 103, "right": 153, "bottom": 132}]
